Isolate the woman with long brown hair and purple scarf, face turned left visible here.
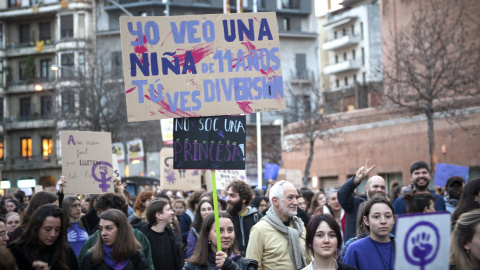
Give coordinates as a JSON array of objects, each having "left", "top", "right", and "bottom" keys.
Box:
[{"left": 81, "top": 209, "right": 148, "bottom": 270}]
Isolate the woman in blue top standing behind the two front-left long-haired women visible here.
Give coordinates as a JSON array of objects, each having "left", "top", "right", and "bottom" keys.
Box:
[{"left": 62, "top": 195, "right": 88, "bottom": 256}]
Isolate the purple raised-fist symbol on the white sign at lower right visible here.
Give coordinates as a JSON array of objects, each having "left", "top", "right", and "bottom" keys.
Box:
[{"left": 403, "top": 221, "right": 440, "bottom": 270}]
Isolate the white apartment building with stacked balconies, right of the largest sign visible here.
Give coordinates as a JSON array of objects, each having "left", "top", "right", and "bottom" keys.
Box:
[{"left": 319, "top": 0, "right": 382, "bottom": 113}]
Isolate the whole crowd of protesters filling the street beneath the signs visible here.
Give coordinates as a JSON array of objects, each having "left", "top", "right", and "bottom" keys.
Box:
[{"left": 0, "top": 160, "right": 480, "bottom": 270}]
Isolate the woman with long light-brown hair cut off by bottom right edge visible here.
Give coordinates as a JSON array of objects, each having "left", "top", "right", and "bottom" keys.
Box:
[{"left": 450, "top": 209, "right": 480, "bottom": 270}]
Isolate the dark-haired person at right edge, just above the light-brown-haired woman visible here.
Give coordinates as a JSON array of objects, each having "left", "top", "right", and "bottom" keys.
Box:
[{"left": 452, "top": 178, "right": 480, "bottom": 227}]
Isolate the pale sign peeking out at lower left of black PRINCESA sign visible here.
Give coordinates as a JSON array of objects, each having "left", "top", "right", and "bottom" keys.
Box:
[{"left": 160, "top": 147, "right": 202, "bottom": 190}]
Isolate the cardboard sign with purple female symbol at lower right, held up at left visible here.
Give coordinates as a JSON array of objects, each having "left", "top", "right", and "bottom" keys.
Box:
[{"left": 60, "top": 130, "right": 114, "bottom": 194}]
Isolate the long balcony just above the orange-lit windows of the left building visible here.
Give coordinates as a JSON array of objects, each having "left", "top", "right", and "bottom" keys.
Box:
[{"left": 4, "top": 114, "right": 57, "bottom": 130}]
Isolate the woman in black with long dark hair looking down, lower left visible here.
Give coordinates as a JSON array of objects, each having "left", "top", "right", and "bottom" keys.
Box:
[{"left": 8, "top": 204, "right": 78, "bottom": 270}]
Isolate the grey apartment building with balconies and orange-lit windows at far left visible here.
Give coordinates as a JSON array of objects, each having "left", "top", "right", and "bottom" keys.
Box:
[{"left": 0, "top": 0, "right": 95, "bottom": 190}]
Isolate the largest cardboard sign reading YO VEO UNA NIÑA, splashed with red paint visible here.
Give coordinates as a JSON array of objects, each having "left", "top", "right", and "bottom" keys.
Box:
[{"left": 120, "top": 12, "right": 285, "bottom": 121}]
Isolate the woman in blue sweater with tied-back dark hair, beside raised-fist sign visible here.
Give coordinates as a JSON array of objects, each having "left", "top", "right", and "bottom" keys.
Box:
[{"left": 343, "top": 197, "right": 395, "bottom": 270}]
